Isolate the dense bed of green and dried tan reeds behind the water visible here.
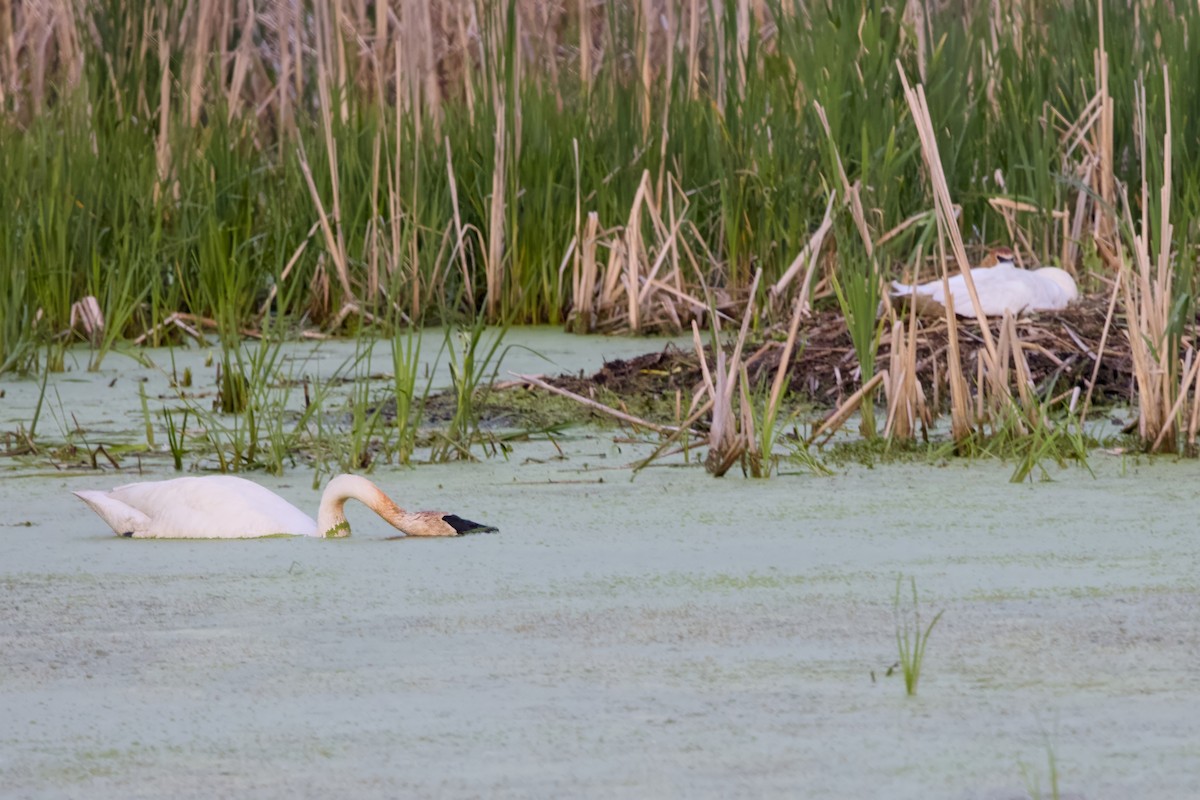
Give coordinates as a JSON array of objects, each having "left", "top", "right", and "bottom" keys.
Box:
[{"left": 7, "top": 0, "right": 1200, "bottom": 462}]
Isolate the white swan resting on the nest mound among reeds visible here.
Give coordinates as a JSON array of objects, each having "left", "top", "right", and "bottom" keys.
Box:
[{"left": 892, "top": 247, "right": 1079, "bottom": 317}]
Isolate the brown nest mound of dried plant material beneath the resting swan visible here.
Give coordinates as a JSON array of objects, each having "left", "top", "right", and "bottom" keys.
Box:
[{"left": 550, "top": 295, "right": 1133, "bottom": 405}]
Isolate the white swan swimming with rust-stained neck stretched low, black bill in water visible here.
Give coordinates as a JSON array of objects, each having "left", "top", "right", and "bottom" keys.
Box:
[{"left": 74, "top": 475, "right": 496, "bottom": 539}]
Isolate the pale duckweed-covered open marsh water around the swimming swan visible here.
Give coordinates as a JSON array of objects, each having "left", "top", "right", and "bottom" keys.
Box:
[{"left": 0, "top": 331, "right": 1200, "bottom": 800}]
